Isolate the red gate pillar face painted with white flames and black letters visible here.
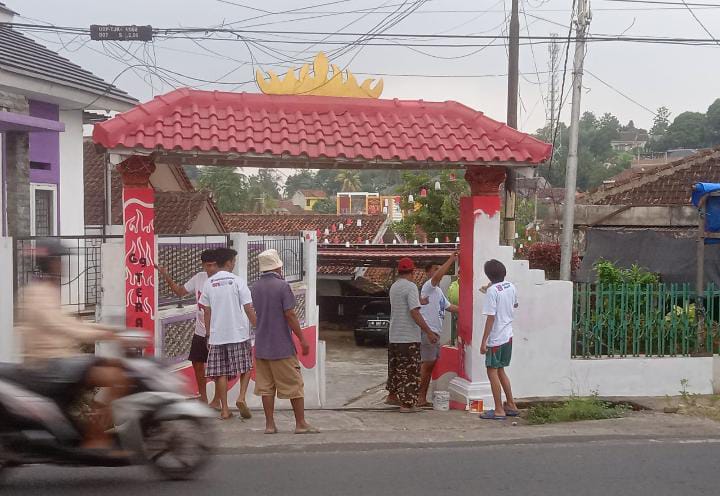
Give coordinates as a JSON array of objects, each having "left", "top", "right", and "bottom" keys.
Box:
[{"left": 123, "top": 188, "right": 156, "bottom": 355}]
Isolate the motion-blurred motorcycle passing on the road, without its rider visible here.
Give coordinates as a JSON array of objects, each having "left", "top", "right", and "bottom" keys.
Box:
[{"left": 0, "top": 332, "right": 215, "bottom": 480}]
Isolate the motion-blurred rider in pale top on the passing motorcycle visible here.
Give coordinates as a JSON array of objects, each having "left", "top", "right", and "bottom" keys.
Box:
[{"left": 18, "top": 238, "right": 129, "bottom": 449}]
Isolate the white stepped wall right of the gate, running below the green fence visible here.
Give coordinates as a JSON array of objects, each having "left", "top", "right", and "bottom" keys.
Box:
[{"left": 449, "top": 196, "right": 720, "bottom": 408}]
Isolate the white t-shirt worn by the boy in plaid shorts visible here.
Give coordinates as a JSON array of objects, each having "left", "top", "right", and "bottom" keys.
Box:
[{"left": 200, "top": 270, "right": 252, "bottom": 345}]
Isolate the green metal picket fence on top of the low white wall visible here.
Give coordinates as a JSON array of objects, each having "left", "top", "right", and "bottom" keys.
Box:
[{"left": 572, "top": 283, "right": 720, "bottom": 358}]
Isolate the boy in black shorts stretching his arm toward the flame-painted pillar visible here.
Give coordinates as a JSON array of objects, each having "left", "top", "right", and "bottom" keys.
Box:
[{"left": 156, "top": 250, "right": 218, "bottom": 405}]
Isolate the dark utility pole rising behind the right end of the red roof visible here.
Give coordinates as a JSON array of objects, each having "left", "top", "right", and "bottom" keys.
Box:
[{"left": 503, "top": 0, "right": 520, "bottom": 246}]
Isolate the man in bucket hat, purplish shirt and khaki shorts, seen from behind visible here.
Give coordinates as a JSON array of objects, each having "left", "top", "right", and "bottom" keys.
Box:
[{"left": 252, "top": 249, "right": 320, "bottom": 434}]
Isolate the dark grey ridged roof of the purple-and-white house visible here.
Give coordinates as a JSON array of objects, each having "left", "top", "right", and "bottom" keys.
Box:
[{"left": 0, "top": 26, "right": 137, "bottom": 104}]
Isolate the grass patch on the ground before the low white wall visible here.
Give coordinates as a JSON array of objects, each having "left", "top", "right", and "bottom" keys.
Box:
[{"left": 527, "top": 396, "right": 627, "bottom": 424}]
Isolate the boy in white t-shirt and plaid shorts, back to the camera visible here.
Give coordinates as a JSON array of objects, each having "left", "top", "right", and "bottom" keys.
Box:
[{"left": 200, "top": 248, "right": 257, "bottom": 420}]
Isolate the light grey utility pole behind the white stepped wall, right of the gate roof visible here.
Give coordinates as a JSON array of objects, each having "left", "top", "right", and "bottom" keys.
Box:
[{"left": 560, "top": 0, "right": 592, "bottom": 281}]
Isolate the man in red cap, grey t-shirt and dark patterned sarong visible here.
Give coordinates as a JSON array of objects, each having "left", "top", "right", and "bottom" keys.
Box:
[{"left": 386, "top": 258, "right": 438, "bottom": 413}]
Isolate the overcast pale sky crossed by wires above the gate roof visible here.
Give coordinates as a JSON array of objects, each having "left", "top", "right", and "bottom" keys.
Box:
[{"left": 11, "top": 0, "right": 720, "bottom": 136}]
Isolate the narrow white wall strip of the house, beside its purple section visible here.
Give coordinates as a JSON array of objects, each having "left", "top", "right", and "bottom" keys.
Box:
[{"left": 59, "top": 110, "right": 85, "bottom": 236}]
